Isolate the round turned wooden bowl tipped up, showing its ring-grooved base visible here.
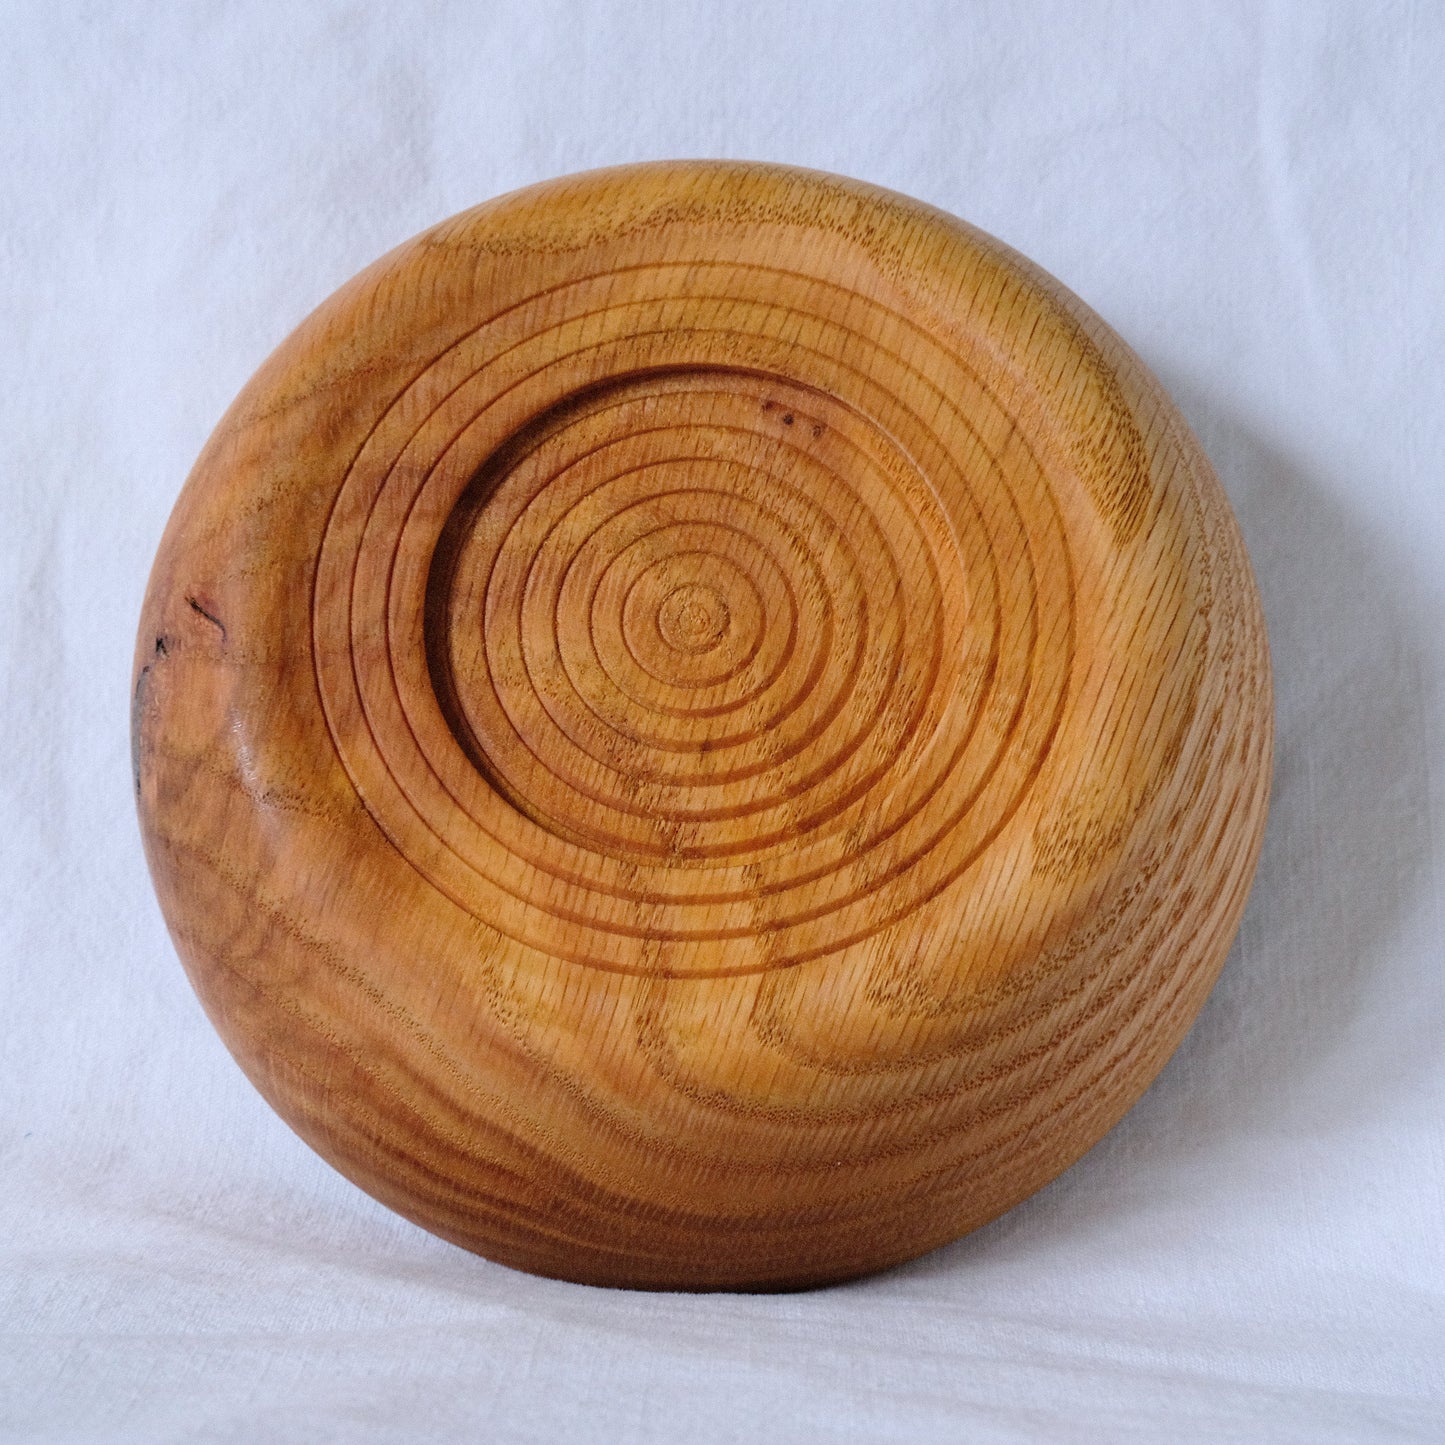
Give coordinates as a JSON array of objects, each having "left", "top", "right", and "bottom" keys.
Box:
[{"left": 133, "top": 163, "right": 1272, "bottom": 1289}]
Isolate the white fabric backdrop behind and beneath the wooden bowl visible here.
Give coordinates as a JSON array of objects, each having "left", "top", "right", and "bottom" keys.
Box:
[{"left": 0, "top": 0, "right": 1445, "bottom": 1445}]
